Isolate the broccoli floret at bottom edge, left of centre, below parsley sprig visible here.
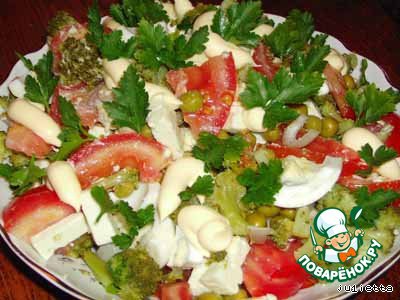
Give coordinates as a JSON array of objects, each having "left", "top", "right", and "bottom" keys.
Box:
[{"left": 107, "top": 248, "right": 163, "bottom": 300}]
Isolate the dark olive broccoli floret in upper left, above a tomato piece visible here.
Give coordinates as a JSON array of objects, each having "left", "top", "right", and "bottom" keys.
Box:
[{"left": 59, "top": 37, "right": 102, "bottom": 87}]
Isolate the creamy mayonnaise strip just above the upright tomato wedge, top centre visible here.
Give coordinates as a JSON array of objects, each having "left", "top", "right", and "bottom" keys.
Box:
[{"left": 205, "top": 32, "right": 254, "bottom": 69}]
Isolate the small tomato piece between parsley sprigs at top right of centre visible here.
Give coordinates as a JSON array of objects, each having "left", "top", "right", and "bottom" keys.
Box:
[{"left": 253, "top": 43, "right": 280, "bottom": 81}]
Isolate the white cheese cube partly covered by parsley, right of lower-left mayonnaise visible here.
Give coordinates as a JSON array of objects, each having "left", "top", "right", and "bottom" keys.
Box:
[{"left": 81, "top": 190, "right": 119, "bottom": 246}]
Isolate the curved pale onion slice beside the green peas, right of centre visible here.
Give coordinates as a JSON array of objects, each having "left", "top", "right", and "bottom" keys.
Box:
[{"left": 282, "top": 115, "right": 319, "bottom": 148}]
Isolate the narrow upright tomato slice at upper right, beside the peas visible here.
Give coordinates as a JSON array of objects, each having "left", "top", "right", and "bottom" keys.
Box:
[{"left": 324, "top": 64, "right": 356, "bottom": 120}]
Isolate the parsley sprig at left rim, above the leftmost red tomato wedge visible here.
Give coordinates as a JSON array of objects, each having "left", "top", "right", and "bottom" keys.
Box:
[{"left": 0, "top": 157, "right": 46, "bottom": 196}]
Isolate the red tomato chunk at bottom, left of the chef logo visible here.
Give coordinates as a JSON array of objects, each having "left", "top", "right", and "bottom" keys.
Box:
[{"left": 243, "top": 241, "right": 310, "bottom": 299}]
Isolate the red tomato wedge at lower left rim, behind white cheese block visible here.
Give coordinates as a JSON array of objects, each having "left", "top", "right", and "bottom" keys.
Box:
[{"left": 3, "top": 186, "right": 75, "bottom": 242}]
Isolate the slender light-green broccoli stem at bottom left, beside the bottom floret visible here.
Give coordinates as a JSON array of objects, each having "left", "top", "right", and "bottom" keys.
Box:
[{"left": 82, "top": 250, "right": 118, "bottom": 294}]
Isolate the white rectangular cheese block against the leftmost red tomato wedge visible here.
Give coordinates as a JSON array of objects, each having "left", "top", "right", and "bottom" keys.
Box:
[{"left": 31, "top": 213, "right": 89, "bottom": 260}]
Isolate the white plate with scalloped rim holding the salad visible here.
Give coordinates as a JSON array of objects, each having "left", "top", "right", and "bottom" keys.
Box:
[{"left": 0, "top": 15, "right": 400, "bottom": 300}]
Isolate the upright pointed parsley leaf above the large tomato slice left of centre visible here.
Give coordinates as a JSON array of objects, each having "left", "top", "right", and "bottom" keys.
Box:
[{"left": 103, "top": 65, "right": 149, "bottom": 132}]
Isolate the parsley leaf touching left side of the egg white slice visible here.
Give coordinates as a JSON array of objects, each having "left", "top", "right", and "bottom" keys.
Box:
[{"left": 237, "top": 159, "right": 283, "bottom": 207}]
